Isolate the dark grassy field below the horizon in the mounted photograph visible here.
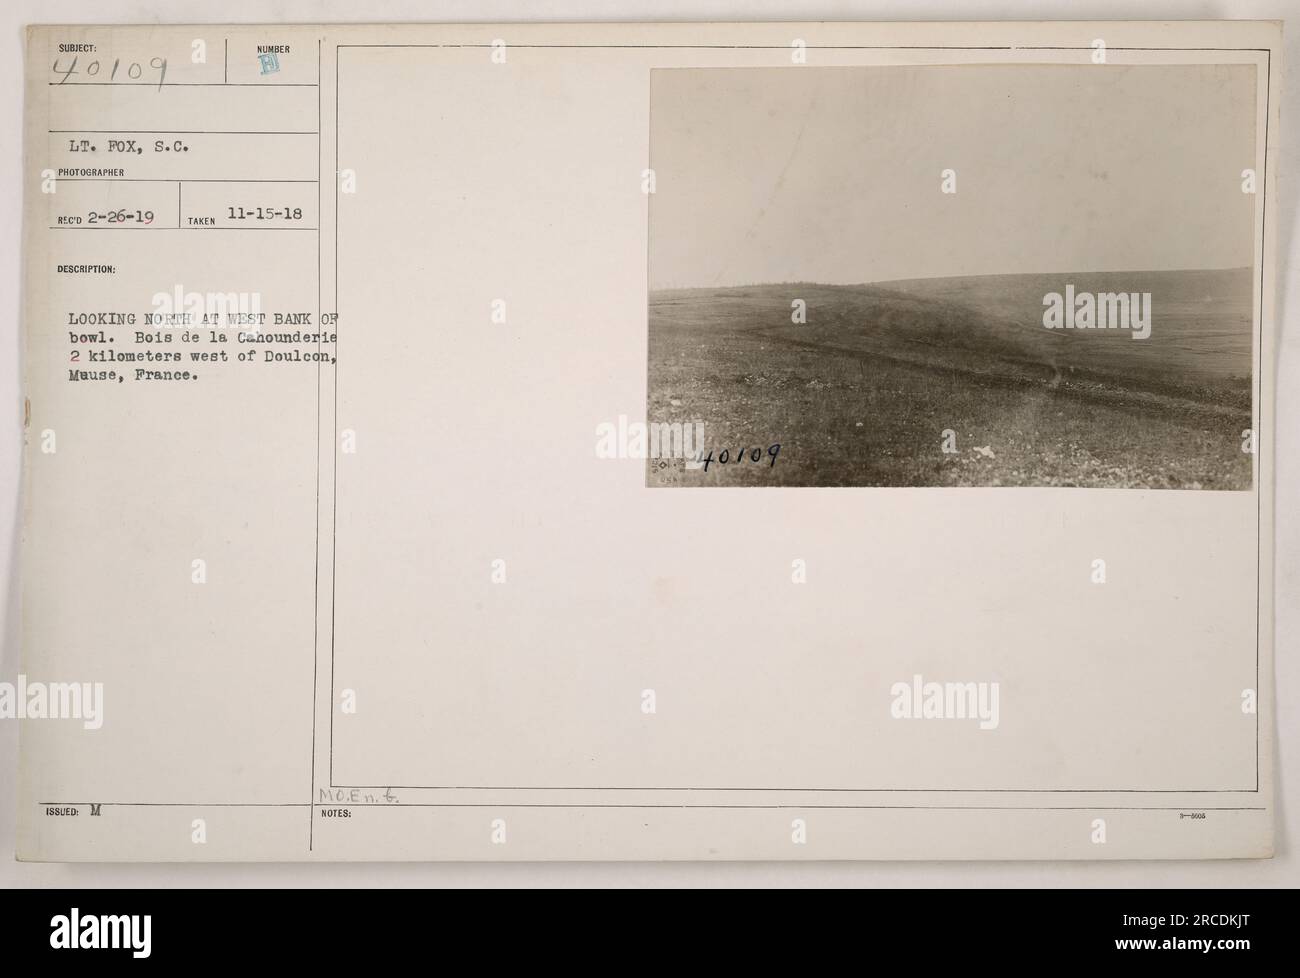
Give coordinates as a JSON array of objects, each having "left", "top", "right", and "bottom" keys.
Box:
[{"left": 647, "top": 269, "right": 1252, "bottom": 489}]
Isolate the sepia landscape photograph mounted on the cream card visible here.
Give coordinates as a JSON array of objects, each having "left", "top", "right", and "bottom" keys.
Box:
[{"left": 646, "top": 64, "right": 1262, "bottom": 489}]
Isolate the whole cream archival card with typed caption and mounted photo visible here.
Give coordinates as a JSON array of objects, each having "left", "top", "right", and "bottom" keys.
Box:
[{"left": 17, "top": 22, "right": 1286, "bottom": 862}]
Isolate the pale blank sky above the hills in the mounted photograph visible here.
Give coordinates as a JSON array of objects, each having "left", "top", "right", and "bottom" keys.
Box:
[{"left": 650, "top": 65, "right": 1256, "bottom": 289}]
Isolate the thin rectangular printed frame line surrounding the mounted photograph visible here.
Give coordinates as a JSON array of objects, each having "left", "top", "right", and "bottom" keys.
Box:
[{"left": 325, "top": 43, "right": 1273, "bottom": 810}]
